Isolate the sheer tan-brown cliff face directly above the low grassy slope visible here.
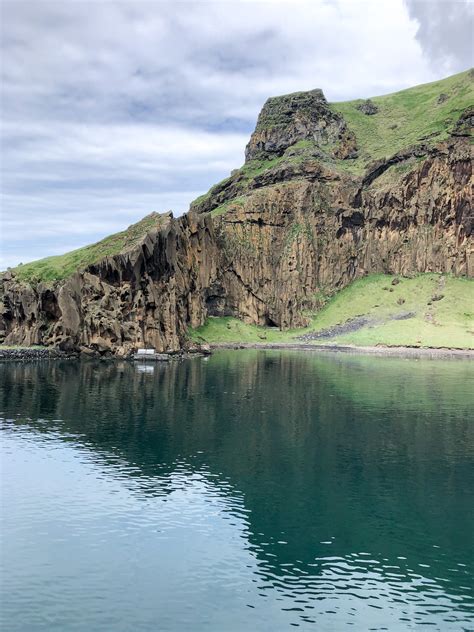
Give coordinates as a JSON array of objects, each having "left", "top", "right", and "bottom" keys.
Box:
[{"left": 207, "top": 136, "right": 474, "bottom": 328}]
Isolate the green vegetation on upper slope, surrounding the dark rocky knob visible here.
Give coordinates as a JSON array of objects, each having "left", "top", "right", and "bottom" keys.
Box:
[{"left": 191, "top": 69, "right": 474, "bottom": 213}]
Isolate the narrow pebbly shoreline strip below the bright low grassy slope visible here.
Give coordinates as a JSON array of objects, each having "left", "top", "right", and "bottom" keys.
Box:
[{"left": 209, "top": 342, "right": 474, "bottom": 360}]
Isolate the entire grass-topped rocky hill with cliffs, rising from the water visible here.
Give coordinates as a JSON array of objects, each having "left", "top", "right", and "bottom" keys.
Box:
[{"left": 0, "top": 70, "right": 474, "bottom": 356}]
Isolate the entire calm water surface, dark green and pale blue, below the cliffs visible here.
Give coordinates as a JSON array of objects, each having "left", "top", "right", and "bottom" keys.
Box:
[{"left": 0, "top": 351, "right": 474, "bottom": 632}]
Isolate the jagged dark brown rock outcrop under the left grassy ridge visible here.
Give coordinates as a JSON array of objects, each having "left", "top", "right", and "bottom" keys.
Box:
[{"left": 2, "top": 214, "right": 218, "bottom": 355}]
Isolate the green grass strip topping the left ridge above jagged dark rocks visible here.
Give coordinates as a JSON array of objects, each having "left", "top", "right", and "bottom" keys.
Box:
[{"left": 13, "top": 213, "right": 163, "bottom": 283}]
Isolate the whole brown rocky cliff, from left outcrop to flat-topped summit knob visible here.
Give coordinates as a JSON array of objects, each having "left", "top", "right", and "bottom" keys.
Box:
[{"left": 0, "top": 76, "right": 474, "bottom": 355}]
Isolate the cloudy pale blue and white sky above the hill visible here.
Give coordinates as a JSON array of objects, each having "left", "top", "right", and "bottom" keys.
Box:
[{"left": 0, "top": 0, "right": 474, "bottom": 269}]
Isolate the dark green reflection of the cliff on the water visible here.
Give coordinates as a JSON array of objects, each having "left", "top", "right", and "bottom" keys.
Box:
[{"left": 0, "top": 351, "right": 474, "bottom": 629}]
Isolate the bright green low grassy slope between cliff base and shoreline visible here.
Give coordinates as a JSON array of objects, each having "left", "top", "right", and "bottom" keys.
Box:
[{"left": 190, "top": 274, "right": 474, "bottom": 349}]
